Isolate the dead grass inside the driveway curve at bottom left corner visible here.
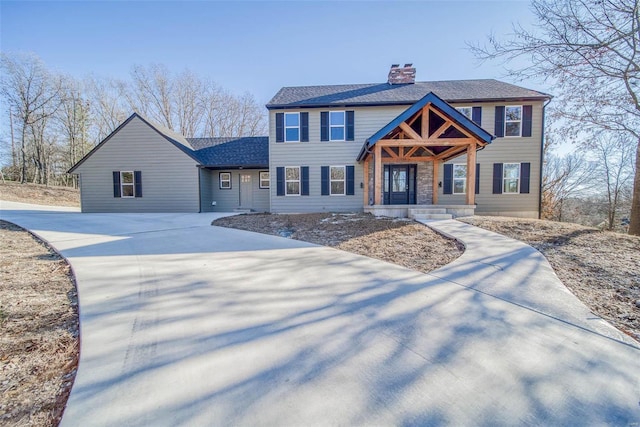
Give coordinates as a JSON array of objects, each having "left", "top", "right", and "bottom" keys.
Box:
[{"left": 0, "top": 221, "right": 78, "bottom": 426}]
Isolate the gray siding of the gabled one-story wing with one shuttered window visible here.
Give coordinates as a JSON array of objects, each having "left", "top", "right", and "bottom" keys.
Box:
[{"left": 75, "top": 118, "right": 200, "bottom": 212}]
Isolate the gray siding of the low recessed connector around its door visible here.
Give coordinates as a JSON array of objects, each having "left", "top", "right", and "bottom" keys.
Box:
[{"left": 209, "top": 169, "right": 269, "bottom": 212}]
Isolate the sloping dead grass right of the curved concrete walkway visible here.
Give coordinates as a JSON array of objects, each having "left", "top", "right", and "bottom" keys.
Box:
[{"left": 462, "top": 216, "right": 640, "bottom": 341}]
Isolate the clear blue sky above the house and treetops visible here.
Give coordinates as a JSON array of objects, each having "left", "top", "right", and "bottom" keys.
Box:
[{"left": 0, "top": 0, "right": 546, "bottom": 103}]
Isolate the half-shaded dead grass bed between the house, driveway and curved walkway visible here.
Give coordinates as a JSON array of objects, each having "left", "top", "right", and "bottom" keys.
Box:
[{"left": 213, "top": 213, "right": 463, "bottom": 273}]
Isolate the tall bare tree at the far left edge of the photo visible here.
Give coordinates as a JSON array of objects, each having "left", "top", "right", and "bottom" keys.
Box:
[{"left": 0, "top": 53, "right": 61, "bottom": 183}]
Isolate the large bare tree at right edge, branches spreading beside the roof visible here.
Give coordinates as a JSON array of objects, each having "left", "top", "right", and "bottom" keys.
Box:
[{"left": 471, "top": 0, "right": 640, "bottom": 235}]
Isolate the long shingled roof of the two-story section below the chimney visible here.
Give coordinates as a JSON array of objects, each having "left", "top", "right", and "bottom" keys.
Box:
[{"left": 267, "top": 79, "right": 551, "bottom": 109}]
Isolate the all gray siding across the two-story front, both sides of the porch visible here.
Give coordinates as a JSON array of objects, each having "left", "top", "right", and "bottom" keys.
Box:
[{"left": 269, "top": 101, "right": 543, "bottom": 217}]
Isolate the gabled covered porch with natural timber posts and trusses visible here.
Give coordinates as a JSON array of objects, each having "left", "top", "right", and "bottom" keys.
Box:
[{"left": 358, "top": 93, "right": 494, "bottom": 217}]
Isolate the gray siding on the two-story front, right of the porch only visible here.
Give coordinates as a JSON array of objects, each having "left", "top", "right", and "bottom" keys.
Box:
[{"left": 438, "top": 102, "right": 543, "bottom": 218}]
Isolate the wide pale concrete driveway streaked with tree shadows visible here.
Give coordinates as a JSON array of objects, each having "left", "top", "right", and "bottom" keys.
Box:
[{"left": 1, "top": 202, "right": 640, "bottom": 426}]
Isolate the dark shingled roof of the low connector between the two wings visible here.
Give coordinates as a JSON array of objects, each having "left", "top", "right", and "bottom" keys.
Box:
[{"left": 187, "top": 136, "right": 269, "bottom": 169}]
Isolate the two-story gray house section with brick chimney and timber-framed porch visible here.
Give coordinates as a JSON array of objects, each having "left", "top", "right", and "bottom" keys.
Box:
[{"left": 267, "top": 64, "right": 550, "bottom": 218}]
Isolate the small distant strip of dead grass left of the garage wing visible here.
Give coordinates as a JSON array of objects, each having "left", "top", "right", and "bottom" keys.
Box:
[{"left": 0, "top": 181, "right": 80, "bottom": 207}]
